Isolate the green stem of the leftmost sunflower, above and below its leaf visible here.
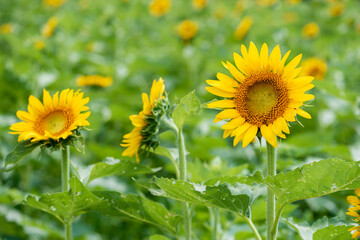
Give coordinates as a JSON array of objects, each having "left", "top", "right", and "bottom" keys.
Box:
[{"left": 61, "top": 146, "right": 72, "bottom": 240}]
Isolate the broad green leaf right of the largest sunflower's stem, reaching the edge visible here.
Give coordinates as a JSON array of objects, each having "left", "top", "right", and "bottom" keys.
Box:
[{"left": 264, "top": 158, "right": 360, "bottom": 207}]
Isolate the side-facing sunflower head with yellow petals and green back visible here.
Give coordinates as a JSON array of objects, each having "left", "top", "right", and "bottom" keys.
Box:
[{"left": 120, "top": 78, "right": 171, "bottom": 162}]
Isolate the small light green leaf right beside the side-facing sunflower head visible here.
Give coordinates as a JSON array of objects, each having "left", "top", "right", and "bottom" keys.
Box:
[{"left": 172, "top": 90, "right": 200, "bottom": 129}]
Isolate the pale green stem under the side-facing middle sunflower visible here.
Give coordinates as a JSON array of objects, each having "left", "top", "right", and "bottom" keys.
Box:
[{"left": 178, "top": 128, "right": 191, "bottom": 240}]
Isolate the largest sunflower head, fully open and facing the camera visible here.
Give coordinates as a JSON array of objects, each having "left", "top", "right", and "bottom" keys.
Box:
[{"left": 206, "top": 42, "right": 314, "bottom": 147}]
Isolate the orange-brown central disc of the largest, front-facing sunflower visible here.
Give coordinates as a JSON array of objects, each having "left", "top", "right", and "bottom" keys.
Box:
[{"left": 234, "top": 72, "right": 289, "bottom": 127}]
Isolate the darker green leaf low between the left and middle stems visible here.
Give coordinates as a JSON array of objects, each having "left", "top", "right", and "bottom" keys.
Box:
[{"left": 94, "top": 191, "right": 181, "bottom": 235}]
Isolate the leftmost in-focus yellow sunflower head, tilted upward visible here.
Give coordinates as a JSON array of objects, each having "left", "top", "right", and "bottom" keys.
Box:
[{"left": 10, "top": 89, "right": 90, "bottom": 142}]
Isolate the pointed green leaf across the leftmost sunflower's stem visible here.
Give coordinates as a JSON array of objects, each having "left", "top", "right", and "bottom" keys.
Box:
[{"left": 25, "top": 177, "right": 103, "bottom": 223}]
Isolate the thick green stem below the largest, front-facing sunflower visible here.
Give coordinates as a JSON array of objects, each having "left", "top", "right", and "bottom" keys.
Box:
[{"left": 266, "top": 142, "right": 277, "bottom": 240}]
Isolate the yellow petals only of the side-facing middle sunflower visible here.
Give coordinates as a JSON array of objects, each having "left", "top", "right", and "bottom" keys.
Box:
[{"left": 120, "top": 78, "right": 165, "bottom": 162}]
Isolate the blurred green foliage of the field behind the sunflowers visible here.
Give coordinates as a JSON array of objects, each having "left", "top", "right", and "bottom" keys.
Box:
[{"left": 0, "top": 0, "right": 360, "bottom": 239}]
